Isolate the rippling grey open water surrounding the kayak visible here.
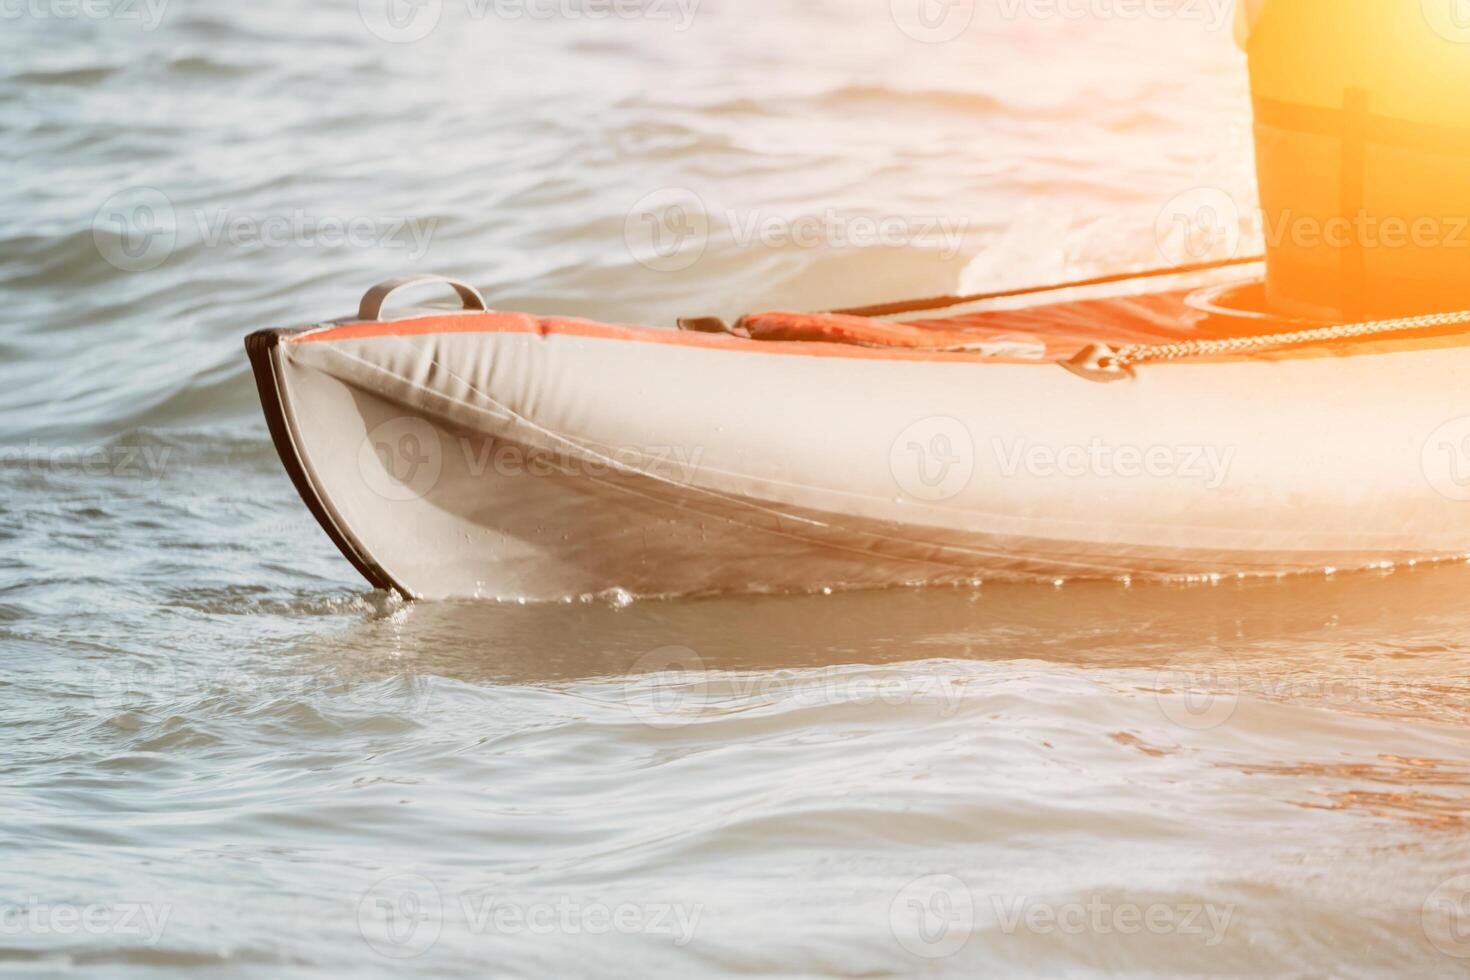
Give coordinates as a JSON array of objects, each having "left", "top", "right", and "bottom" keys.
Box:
[{"left": 0, "top": 0, "right": 1470, "bottom": 977}]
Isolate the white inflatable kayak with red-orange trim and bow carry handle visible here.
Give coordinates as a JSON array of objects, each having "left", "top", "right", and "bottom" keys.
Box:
[{"left": 247, "top": 268, "right": 1470, "bottom": 601}]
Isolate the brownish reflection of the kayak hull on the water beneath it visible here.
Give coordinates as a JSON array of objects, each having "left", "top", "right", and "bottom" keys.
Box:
[{"left": 303, "top": 564, "right": 1470, "bottom": 708}]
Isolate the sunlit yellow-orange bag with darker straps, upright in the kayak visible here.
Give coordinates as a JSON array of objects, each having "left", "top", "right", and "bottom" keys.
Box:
[{"left": 1242, "top": 0, "right": 1470, "bottom": 320}]
